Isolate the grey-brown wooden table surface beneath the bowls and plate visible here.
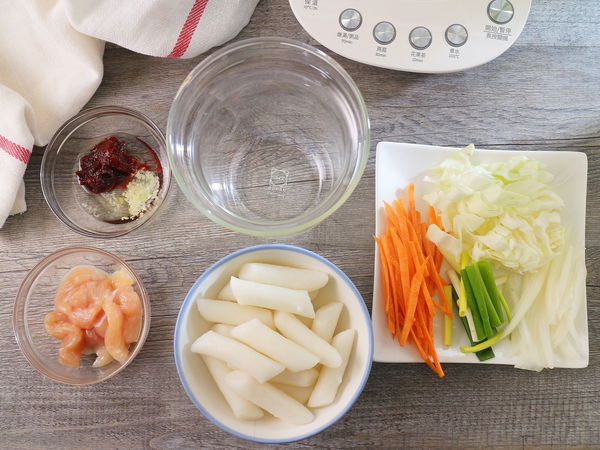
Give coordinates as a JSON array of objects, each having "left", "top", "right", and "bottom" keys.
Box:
[{"left": 0, "top": 0, "right": 600, "bottom": 448}]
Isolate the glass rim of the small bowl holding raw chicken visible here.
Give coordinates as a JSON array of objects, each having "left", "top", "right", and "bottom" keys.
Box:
[{"left": 12, "top": 245, "right": 152, "bottom": 386}]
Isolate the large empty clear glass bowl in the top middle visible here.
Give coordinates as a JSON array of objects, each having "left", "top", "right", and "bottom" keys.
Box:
[{"left": 167, "top": 38, "right": 370, "bottom": 236}]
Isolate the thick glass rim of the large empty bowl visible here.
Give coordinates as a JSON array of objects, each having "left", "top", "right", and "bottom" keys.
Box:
[{"left": 166, "top": 36, "right": 371, "bottom": 237}]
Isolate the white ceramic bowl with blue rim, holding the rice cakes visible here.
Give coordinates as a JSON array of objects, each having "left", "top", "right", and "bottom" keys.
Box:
[{"left": 175, "top": 244, "right": 373, "bottom": 443}]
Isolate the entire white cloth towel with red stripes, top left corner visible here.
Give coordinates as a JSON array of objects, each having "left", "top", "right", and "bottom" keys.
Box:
[{"left": 0, "top": 0, "right": 259, "bottom": 228}]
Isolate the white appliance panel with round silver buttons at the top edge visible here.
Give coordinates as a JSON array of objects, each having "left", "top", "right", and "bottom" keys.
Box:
[{"left": 290, "top": 0, "right": 531, "bottom": 73}]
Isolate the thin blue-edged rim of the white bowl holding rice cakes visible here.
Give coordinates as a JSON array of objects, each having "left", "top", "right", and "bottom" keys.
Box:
[{"left": 173, "top": 244, "right": 374, "bottom": 444}]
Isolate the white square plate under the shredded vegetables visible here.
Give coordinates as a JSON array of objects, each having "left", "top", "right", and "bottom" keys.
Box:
[{"left": 372, "top": 142, "right": 589, "bottom": 368}]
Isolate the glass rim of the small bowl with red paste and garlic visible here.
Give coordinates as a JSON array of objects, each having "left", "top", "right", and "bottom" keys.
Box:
[{"left": 40, "top": 105, "right": 173, "bottom": 239}]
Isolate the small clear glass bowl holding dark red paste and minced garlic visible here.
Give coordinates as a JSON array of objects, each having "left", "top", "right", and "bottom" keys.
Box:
[{"left": 40, "top": 106, "right": 171, "bottom": 238}]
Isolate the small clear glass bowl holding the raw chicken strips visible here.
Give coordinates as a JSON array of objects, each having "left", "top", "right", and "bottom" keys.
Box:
[{"left": 13, "top": 247, "right": 150, "bottom": 386}]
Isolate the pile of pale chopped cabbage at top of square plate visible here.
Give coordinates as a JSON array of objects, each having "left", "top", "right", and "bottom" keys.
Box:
[{"left": 424, "top": 145, "right": 564, "bottom": 273}]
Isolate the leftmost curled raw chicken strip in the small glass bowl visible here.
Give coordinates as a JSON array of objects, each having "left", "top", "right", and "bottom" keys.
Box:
[{"left": 44, "top": 311, "right": 85, "bottom": 368}]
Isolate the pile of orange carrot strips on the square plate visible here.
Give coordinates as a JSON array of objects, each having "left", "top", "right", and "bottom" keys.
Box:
[{"left": 374, "top": 183, "right": 452, "bottom": 377}]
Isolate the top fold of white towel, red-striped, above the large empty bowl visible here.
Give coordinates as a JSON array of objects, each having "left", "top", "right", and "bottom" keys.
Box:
[{"left": 65, "top": 0, "right": 258, "bottom": 58}]
